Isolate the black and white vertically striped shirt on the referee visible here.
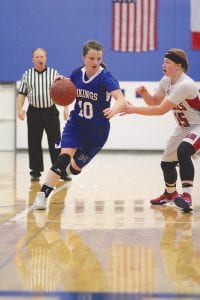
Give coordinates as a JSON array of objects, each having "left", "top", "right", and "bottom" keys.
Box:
[{"left": 18, "top": 67, "right": 58, "bottom": 108}]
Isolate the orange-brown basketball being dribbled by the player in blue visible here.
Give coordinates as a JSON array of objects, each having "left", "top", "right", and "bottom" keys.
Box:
[{"left": 50, "top": 77, "right": 76, "bottom": 106}]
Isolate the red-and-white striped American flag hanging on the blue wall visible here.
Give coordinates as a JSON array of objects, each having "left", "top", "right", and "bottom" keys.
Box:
[{"left": 112, "top": 0, "right": 157, "bottom": 52}]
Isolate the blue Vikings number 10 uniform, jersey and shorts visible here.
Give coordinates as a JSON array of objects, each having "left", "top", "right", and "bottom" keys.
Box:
[{"left": 61, "top": 67, "right": 120, "bottom": 168}]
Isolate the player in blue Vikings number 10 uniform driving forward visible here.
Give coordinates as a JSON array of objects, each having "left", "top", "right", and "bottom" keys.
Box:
[{"left": 33, "top": 40, "right": 126, "bottom": 209}]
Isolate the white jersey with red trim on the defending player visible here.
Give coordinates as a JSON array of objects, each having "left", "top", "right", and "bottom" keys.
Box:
[{"left": 156, "top": 73, "right": 200, "bottom": 128}]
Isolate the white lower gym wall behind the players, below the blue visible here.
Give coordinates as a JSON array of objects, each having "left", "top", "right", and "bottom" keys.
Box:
[{"left": 0, "top": 81, "right": 200, "bottom": 150}]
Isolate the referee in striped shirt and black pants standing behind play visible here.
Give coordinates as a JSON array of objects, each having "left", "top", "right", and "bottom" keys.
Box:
[{"left": 17, "top": 48, "right": 71, "bottom": 181}]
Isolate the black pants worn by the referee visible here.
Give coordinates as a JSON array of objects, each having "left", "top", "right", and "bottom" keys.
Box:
[{"left": 27, "top": 105, "right": 61, "bottom": 176}]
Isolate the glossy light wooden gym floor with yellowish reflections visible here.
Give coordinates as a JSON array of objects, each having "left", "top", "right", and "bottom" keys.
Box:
[{"left": 0, "top": 151, "right": 200, "bottom": 300}]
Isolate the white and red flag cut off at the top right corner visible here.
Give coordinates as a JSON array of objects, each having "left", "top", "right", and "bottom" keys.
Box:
[{"left": 190, "top": 0, "right": 200, "bottom": 50}]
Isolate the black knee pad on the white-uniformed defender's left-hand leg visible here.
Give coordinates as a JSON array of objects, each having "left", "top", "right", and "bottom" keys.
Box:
[{"left": 161, "top": 161, "right": 178, "bottom": 184}]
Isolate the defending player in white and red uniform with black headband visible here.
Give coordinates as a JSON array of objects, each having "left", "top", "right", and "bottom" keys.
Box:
[{"left": 122, "top": 48, "right": 200, "bottom": 212}]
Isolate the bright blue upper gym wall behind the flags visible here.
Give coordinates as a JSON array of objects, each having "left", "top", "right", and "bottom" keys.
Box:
[{"left": 0, "top": 0, "right": 200, "bottom": 82}]
